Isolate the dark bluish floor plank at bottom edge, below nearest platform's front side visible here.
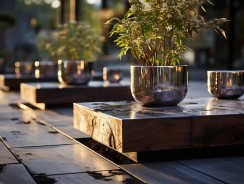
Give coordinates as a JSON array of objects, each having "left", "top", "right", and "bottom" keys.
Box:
[{"left": 121, "top": 161, "right": 223, "bottom": 184}]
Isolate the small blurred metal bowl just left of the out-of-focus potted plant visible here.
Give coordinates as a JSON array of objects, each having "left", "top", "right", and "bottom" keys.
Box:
[{"left": 35, "top": 61, "right": 58, "bottom": 78}]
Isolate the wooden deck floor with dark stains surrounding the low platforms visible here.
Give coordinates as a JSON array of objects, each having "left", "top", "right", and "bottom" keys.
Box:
[{"left": 0, "top": 83, "right": 244, "bottom": 184}]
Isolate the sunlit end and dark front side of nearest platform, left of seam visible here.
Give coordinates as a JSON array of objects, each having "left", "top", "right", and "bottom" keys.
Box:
[{"left": 74, "top": 104, "right": 191, "bottom": 152}]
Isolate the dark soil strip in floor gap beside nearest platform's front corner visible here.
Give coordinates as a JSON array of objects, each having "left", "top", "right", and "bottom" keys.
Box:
[{"left": 77, "top": 139, "right": 136, "bottom": 165}]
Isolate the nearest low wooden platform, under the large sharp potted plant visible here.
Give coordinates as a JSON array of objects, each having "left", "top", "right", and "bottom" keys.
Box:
[{"left": 74, "top": 97, "right": 244, "bottom": 159}]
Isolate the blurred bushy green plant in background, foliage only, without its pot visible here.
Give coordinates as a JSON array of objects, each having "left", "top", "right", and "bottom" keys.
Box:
[{"left": 45, "top": 22, "right": 104, "bottom": 60}]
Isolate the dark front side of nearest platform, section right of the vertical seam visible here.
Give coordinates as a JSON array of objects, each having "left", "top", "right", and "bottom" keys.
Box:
[{"left": 192, "top": 115, "right": 244, "bottom": 147}]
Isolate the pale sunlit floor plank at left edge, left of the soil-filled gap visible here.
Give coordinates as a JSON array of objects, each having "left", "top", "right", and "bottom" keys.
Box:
[{"left": 0, "top": 119, "right": 74, "bottom": 148}]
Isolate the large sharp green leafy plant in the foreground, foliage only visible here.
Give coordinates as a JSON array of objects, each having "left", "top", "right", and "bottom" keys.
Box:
[{"left": 107, "top": 0, "right": 227, "bottom": 66}]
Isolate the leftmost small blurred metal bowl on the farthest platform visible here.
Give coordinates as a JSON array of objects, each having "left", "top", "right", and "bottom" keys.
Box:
[{"left": 15, "top": 61, "right": 34, "bottom": 75}]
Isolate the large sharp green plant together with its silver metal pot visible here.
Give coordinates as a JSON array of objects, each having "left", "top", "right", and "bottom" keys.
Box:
[{"left": 107, "top": 0, "right": 227, "bottom": 106}]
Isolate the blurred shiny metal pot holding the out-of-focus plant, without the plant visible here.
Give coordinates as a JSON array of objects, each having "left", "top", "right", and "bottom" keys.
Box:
[{"left": 58, "top": 60, "right": 93, "bottom": 85}]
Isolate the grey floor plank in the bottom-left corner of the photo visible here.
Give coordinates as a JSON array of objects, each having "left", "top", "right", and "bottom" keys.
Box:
[{"left": 0, "top": 164, "right": 36, "bottom": 184}]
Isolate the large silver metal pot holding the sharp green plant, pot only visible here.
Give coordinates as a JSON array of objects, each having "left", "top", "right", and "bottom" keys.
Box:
[{"left": 131, "top": 65, "right": 188, "bottom": 106}]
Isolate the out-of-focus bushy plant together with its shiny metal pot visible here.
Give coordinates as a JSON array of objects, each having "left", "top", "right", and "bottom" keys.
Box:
[{"left": 41, "top": 22, "right": 104, "bottom": 84}]
